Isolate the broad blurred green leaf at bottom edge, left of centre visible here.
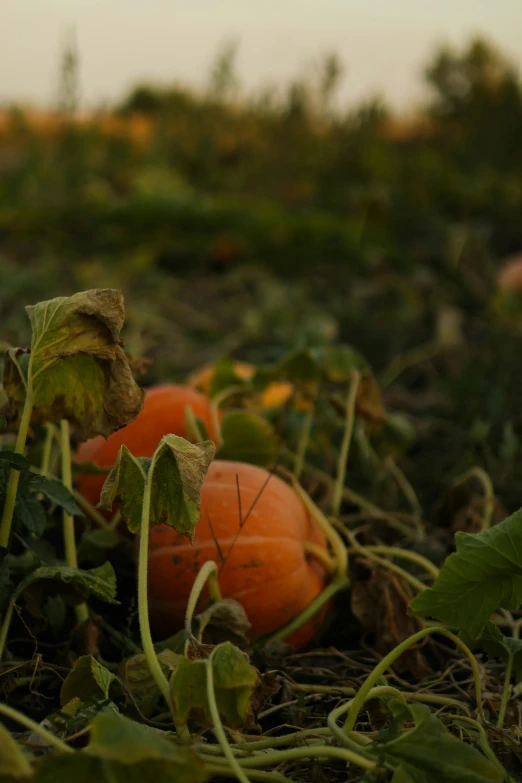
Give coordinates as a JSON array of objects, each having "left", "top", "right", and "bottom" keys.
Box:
[{"left": 34, "top": 712, "right": 208, "bottom": 783}]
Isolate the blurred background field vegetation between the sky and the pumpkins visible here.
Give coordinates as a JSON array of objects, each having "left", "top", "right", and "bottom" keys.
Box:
[{"left": 0, "top": 39, "right": 522, "bottom": 509}]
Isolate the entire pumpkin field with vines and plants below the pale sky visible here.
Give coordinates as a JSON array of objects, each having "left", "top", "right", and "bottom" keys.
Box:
[{"left": 5, "top": 33, "right": 522, "bottom": 783}]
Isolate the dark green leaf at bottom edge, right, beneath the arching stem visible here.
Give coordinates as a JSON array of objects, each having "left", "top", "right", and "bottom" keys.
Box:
[{"left": 371, "top": 704, "right": 505, "bottom": 783}]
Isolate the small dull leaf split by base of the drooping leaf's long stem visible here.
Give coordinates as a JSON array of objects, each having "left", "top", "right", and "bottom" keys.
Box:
[{"left": 118, "top": 646, "right": 178, "bottom": 718}]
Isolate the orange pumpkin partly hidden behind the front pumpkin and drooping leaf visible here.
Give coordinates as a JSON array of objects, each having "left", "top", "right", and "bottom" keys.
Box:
[{"left": 76, "top": 383, "right": 216, "bottom": 506}]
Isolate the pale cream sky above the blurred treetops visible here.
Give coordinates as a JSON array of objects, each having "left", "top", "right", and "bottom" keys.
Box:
[{"left": 0, "top": 0, "right": 522, "bottom": 108}]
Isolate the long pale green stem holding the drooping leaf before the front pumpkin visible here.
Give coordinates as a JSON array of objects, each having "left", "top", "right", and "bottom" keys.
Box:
[{"left": 138, "top": 460, "right": 171, "bottom": 709}]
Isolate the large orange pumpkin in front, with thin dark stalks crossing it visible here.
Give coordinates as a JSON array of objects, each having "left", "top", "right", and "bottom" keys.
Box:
[{"left": 144, "top": 460, "right": 327, "bottom": 648}]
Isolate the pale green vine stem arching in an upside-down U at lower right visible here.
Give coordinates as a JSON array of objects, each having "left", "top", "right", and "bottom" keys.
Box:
[{"left": 344, "top": 626, "right": 486, "bottom": 733}]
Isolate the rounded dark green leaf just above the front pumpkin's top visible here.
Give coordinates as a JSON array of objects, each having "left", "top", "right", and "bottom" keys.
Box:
[{"left": 218, "top": 411, "right": 279, "bottom": 467}]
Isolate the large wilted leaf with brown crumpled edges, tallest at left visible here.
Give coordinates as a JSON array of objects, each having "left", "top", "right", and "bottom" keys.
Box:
[{"left": 3, "top": 288, "right": 143, "bottom": 440}]
